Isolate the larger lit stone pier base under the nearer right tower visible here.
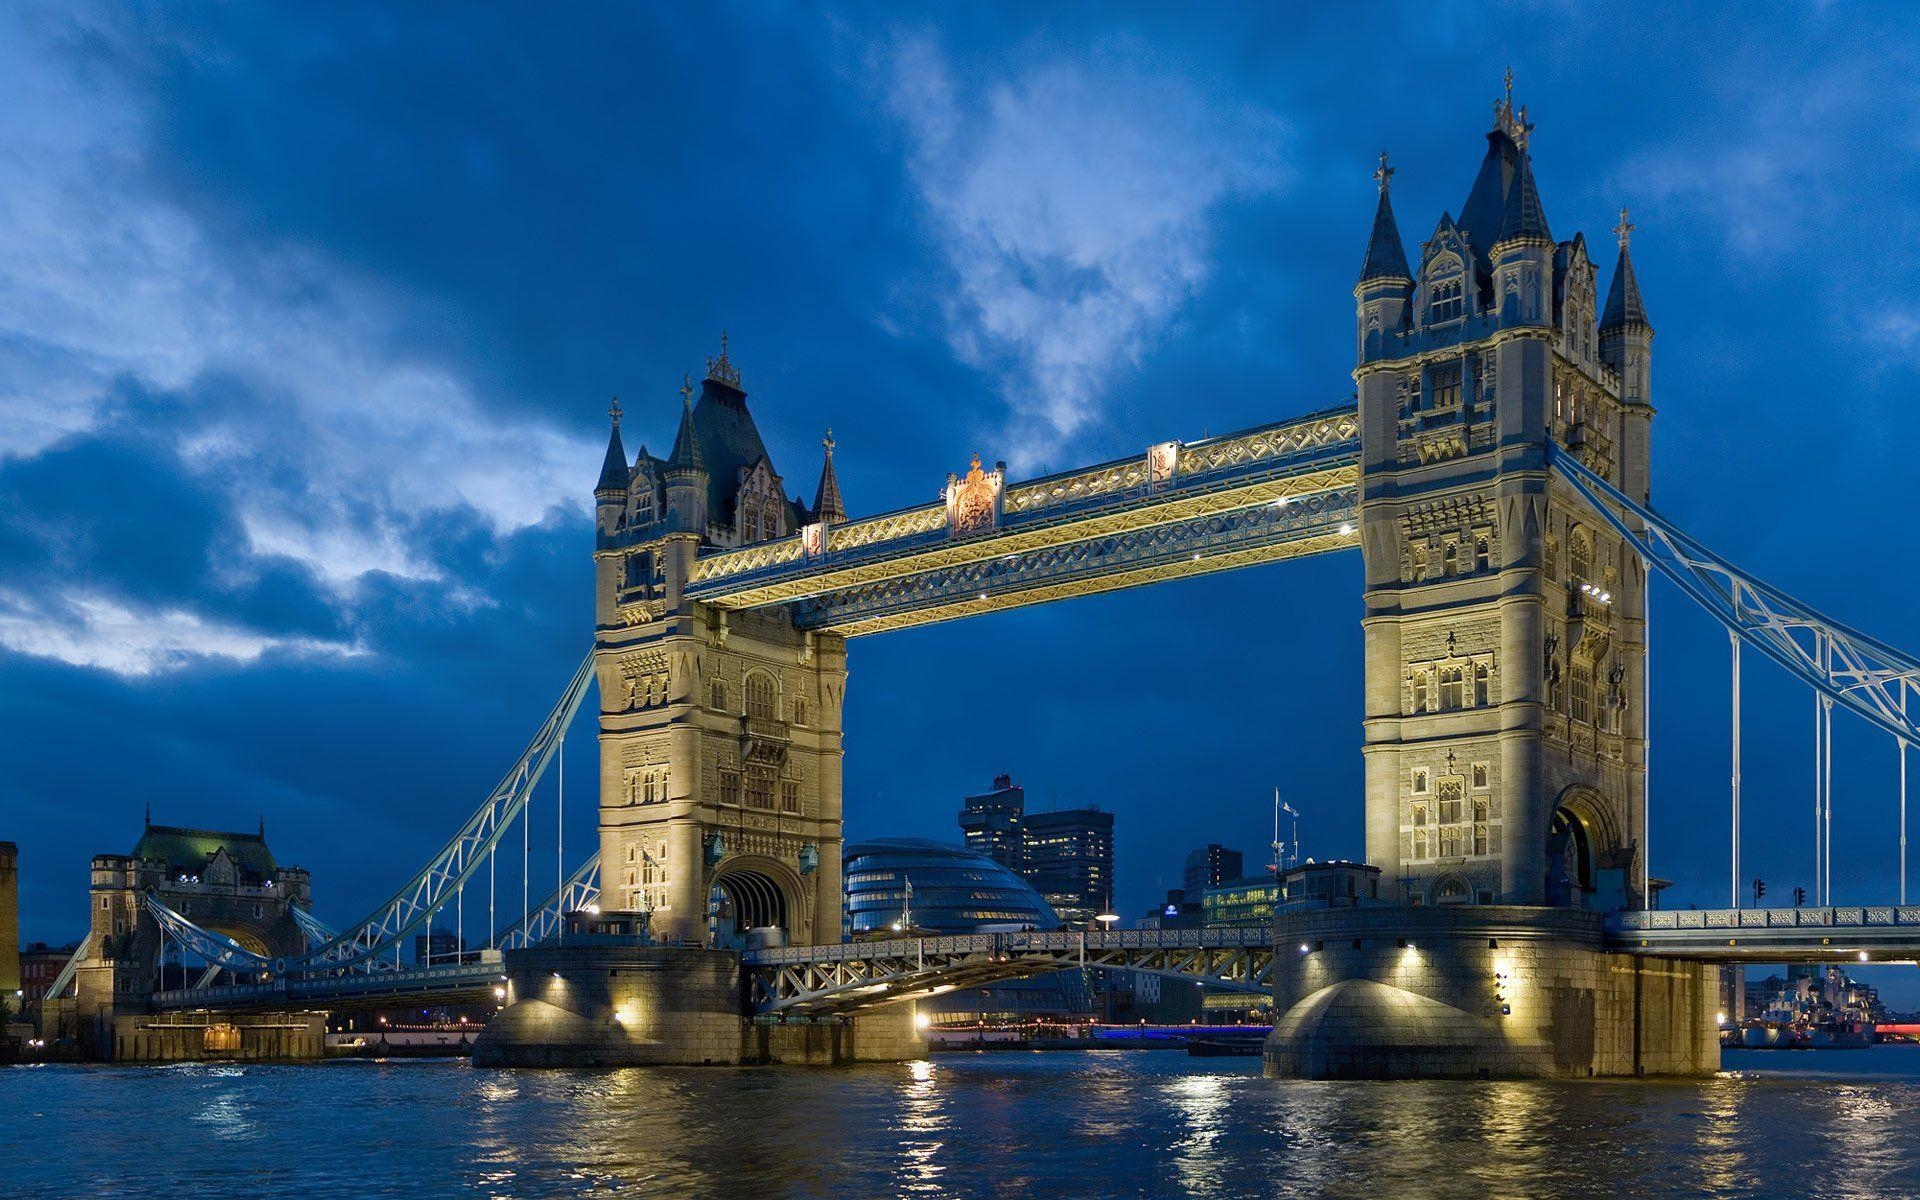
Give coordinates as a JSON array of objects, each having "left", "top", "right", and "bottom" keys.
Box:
[{"left": 1263, "top": 906, "right": 1720, "bottom": 1079}]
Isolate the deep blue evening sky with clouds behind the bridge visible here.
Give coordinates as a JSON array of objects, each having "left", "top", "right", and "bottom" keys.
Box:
[{"left": 0, "top": 4, "right": 1920, "bottom": 1000}]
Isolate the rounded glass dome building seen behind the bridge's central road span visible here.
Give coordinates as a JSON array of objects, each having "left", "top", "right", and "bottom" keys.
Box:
[{"left": 843, "top": 837, "right": 1092, "bottom": 1023}]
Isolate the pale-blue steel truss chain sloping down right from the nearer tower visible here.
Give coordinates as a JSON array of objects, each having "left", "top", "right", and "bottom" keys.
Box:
[{"left": 1548, "top": 445, "right": 1920, "bottom": 745}]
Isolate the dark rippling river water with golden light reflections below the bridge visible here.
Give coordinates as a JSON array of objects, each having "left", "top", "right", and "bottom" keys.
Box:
[{"left": 0, "top": 1046, "right": 1920, "bottom": 1198}]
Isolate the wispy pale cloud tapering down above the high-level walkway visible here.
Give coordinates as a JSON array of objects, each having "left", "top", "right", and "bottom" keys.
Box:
[{"left": 885, "top": 38, "right": 1290, "bottom": 465}]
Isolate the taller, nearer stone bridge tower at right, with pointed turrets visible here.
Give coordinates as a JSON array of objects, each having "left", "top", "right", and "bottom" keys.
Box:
[{"left": 1354, "top": 91, "right": 1653, "bottom": 908}]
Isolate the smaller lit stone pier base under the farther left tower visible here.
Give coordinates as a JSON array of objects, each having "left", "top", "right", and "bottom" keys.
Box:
[{"left": 474, "top": 935, "right": 925, "bottom": 1068}]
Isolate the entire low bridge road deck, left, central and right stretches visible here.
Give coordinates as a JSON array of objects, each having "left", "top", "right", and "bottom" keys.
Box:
[{"left": 152, "top": 904, "right": 1920, "bottom": 1016}]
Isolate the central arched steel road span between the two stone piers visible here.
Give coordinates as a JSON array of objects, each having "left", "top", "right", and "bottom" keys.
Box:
[{"left": 743, "top": 929, "right": 1273, "bottom": 1016}]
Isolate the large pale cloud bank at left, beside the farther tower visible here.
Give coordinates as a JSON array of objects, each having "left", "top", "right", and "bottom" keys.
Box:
[{"left": 0, "top": 10, "right": 599, "bottom": 674}]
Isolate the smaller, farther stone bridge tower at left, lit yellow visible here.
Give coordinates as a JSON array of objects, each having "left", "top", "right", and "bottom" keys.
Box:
[{"left": 593, "top": 338, "right": 847, "bottom": 943}]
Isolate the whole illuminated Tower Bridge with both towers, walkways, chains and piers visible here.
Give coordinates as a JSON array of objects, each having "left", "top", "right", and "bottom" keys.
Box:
[{"left": 30, "top": 92, "right": 1920, "bottom": 1075}]
